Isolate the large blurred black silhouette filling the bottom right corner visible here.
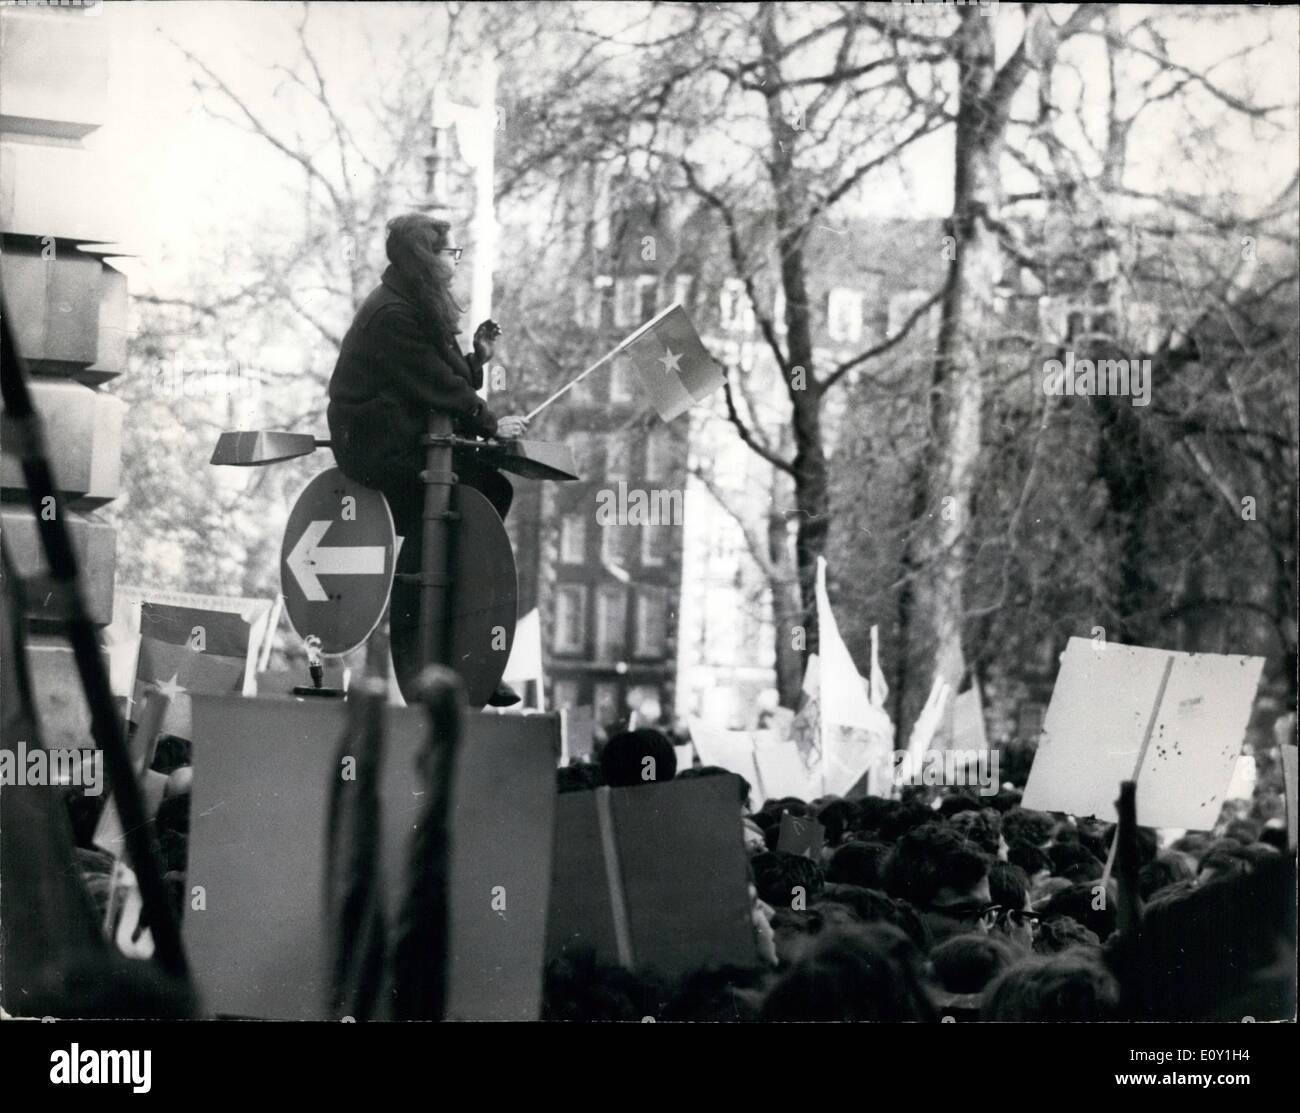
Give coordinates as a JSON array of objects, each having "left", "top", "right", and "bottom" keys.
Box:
[{"left": 1106, "top": 854, "right": 1296, "bottom": 1023}]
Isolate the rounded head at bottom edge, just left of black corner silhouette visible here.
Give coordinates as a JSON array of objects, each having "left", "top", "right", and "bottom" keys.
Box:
[{"left": 980, "top": 948, "right": 1119, "bottom": 1022}]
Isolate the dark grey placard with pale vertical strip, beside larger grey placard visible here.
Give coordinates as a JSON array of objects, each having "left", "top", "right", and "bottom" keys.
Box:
[{"left": 546, "top": 776, "right": 758, "bottom": 978}]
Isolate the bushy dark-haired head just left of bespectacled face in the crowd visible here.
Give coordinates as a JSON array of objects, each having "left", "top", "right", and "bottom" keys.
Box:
[{"left": 885, "top": 823, "right": 997, "bottom": 943}]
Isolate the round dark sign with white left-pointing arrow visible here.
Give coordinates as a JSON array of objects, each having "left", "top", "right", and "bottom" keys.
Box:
[{"left": 280, "top": 468, "right": 397, "bottom": 654}]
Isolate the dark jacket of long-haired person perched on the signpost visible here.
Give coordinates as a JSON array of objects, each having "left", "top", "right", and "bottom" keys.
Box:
[{"left": 326, "top": 267, "right": 497, "bottom": 488}]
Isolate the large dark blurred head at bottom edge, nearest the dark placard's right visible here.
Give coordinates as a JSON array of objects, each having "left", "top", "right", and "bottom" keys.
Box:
[{"left": 759, "top": 923, "right": 935, "bottom": 1021}]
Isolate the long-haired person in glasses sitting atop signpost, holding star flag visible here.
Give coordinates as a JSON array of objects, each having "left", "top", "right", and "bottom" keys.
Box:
[{"left": 326, "top": 213, "right": 528, "bottom": 706}]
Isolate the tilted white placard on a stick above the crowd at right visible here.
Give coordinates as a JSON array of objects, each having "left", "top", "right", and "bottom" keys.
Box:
[{"left": 1022, "top": 637, "right": 1264, "bottom": 831}]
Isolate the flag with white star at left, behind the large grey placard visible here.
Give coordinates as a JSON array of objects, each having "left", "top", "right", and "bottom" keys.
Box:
[{"left": 130, "top": 601, "right": 257, "bottom": 739}]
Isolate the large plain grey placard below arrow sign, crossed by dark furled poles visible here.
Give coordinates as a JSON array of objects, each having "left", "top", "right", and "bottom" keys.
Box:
[{"left": 183, "top": 696, "right": 559, "bottom": 1021}]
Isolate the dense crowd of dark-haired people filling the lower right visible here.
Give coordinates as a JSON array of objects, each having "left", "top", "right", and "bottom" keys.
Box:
[{"left": 58, "top": 729, "right": 1296, "bottom": 1022}]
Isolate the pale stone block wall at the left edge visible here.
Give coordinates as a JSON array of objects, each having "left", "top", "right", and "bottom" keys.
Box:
[{"left": 0, "top": 5, "right": 127, "bottom": 746}]
